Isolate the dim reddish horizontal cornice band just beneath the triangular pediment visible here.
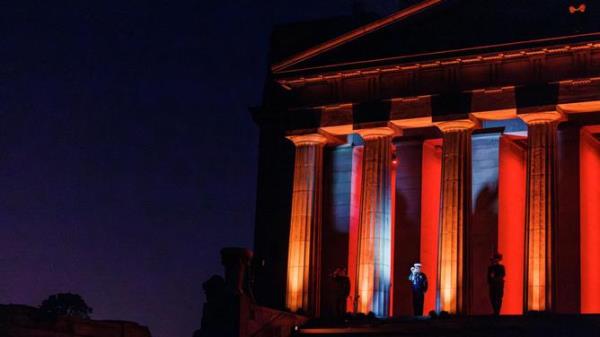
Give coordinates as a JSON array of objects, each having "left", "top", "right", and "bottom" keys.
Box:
[{"left": 274, "top": 41, "right": 600, "bottom": 107}]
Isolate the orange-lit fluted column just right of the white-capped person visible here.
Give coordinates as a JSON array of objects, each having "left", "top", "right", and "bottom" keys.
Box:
[{"left": 432, "top": 120, "right": 476, "bottom": 313}]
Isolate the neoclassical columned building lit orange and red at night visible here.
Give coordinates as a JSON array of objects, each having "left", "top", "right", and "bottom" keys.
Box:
[{"left": 253, "top": 0, "right": 600, "bottom": 317}]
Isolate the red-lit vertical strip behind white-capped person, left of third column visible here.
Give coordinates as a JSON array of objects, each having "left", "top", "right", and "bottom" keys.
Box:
[{"left": 422, "top": 139, "right": 442, "bottom": 313}]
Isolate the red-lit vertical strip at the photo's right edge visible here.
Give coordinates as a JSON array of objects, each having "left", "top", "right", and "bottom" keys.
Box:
[{"left": 579, "top": 126, "right": 600, "bottom": 314}]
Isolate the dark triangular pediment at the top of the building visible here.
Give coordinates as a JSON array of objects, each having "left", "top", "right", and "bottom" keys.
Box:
[{"left": 272, "top": 0, "right": 600, "bottom": 73}]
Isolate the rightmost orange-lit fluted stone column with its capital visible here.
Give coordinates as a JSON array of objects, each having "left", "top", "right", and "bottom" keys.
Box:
[{"left": 519, "top": 112, "right": 560, "bottom": 311}]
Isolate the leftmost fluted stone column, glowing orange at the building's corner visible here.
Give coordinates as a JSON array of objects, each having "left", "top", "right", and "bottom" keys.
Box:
[{"left": 286, "top": 134, "right": 326, "bottom": 316}]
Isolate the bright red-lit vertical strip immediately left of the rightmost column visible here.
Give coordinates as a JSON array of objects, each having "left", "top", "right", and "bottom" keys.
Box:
[{"left": 498, "top": 135, "right": 527, "bottom": 315}]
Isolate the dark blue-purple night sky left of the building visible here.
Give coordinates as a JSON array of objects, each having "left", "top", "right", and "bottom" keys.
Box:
[{"left": 0, "top": 0, "right": 404, "bottom": 337}]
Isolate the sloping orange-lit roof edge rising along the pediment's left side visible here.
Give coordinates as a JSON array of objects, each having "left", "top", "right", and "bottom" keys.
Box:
[{"left": 271, "top": 0, "right": 444, "bottom": 72}]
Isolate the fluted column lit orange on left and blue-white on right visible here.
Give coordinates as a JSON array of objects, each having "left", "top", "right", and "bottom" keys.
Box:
[{"left": 356, "top": 128, "right": 393, "bottom": 317}]
